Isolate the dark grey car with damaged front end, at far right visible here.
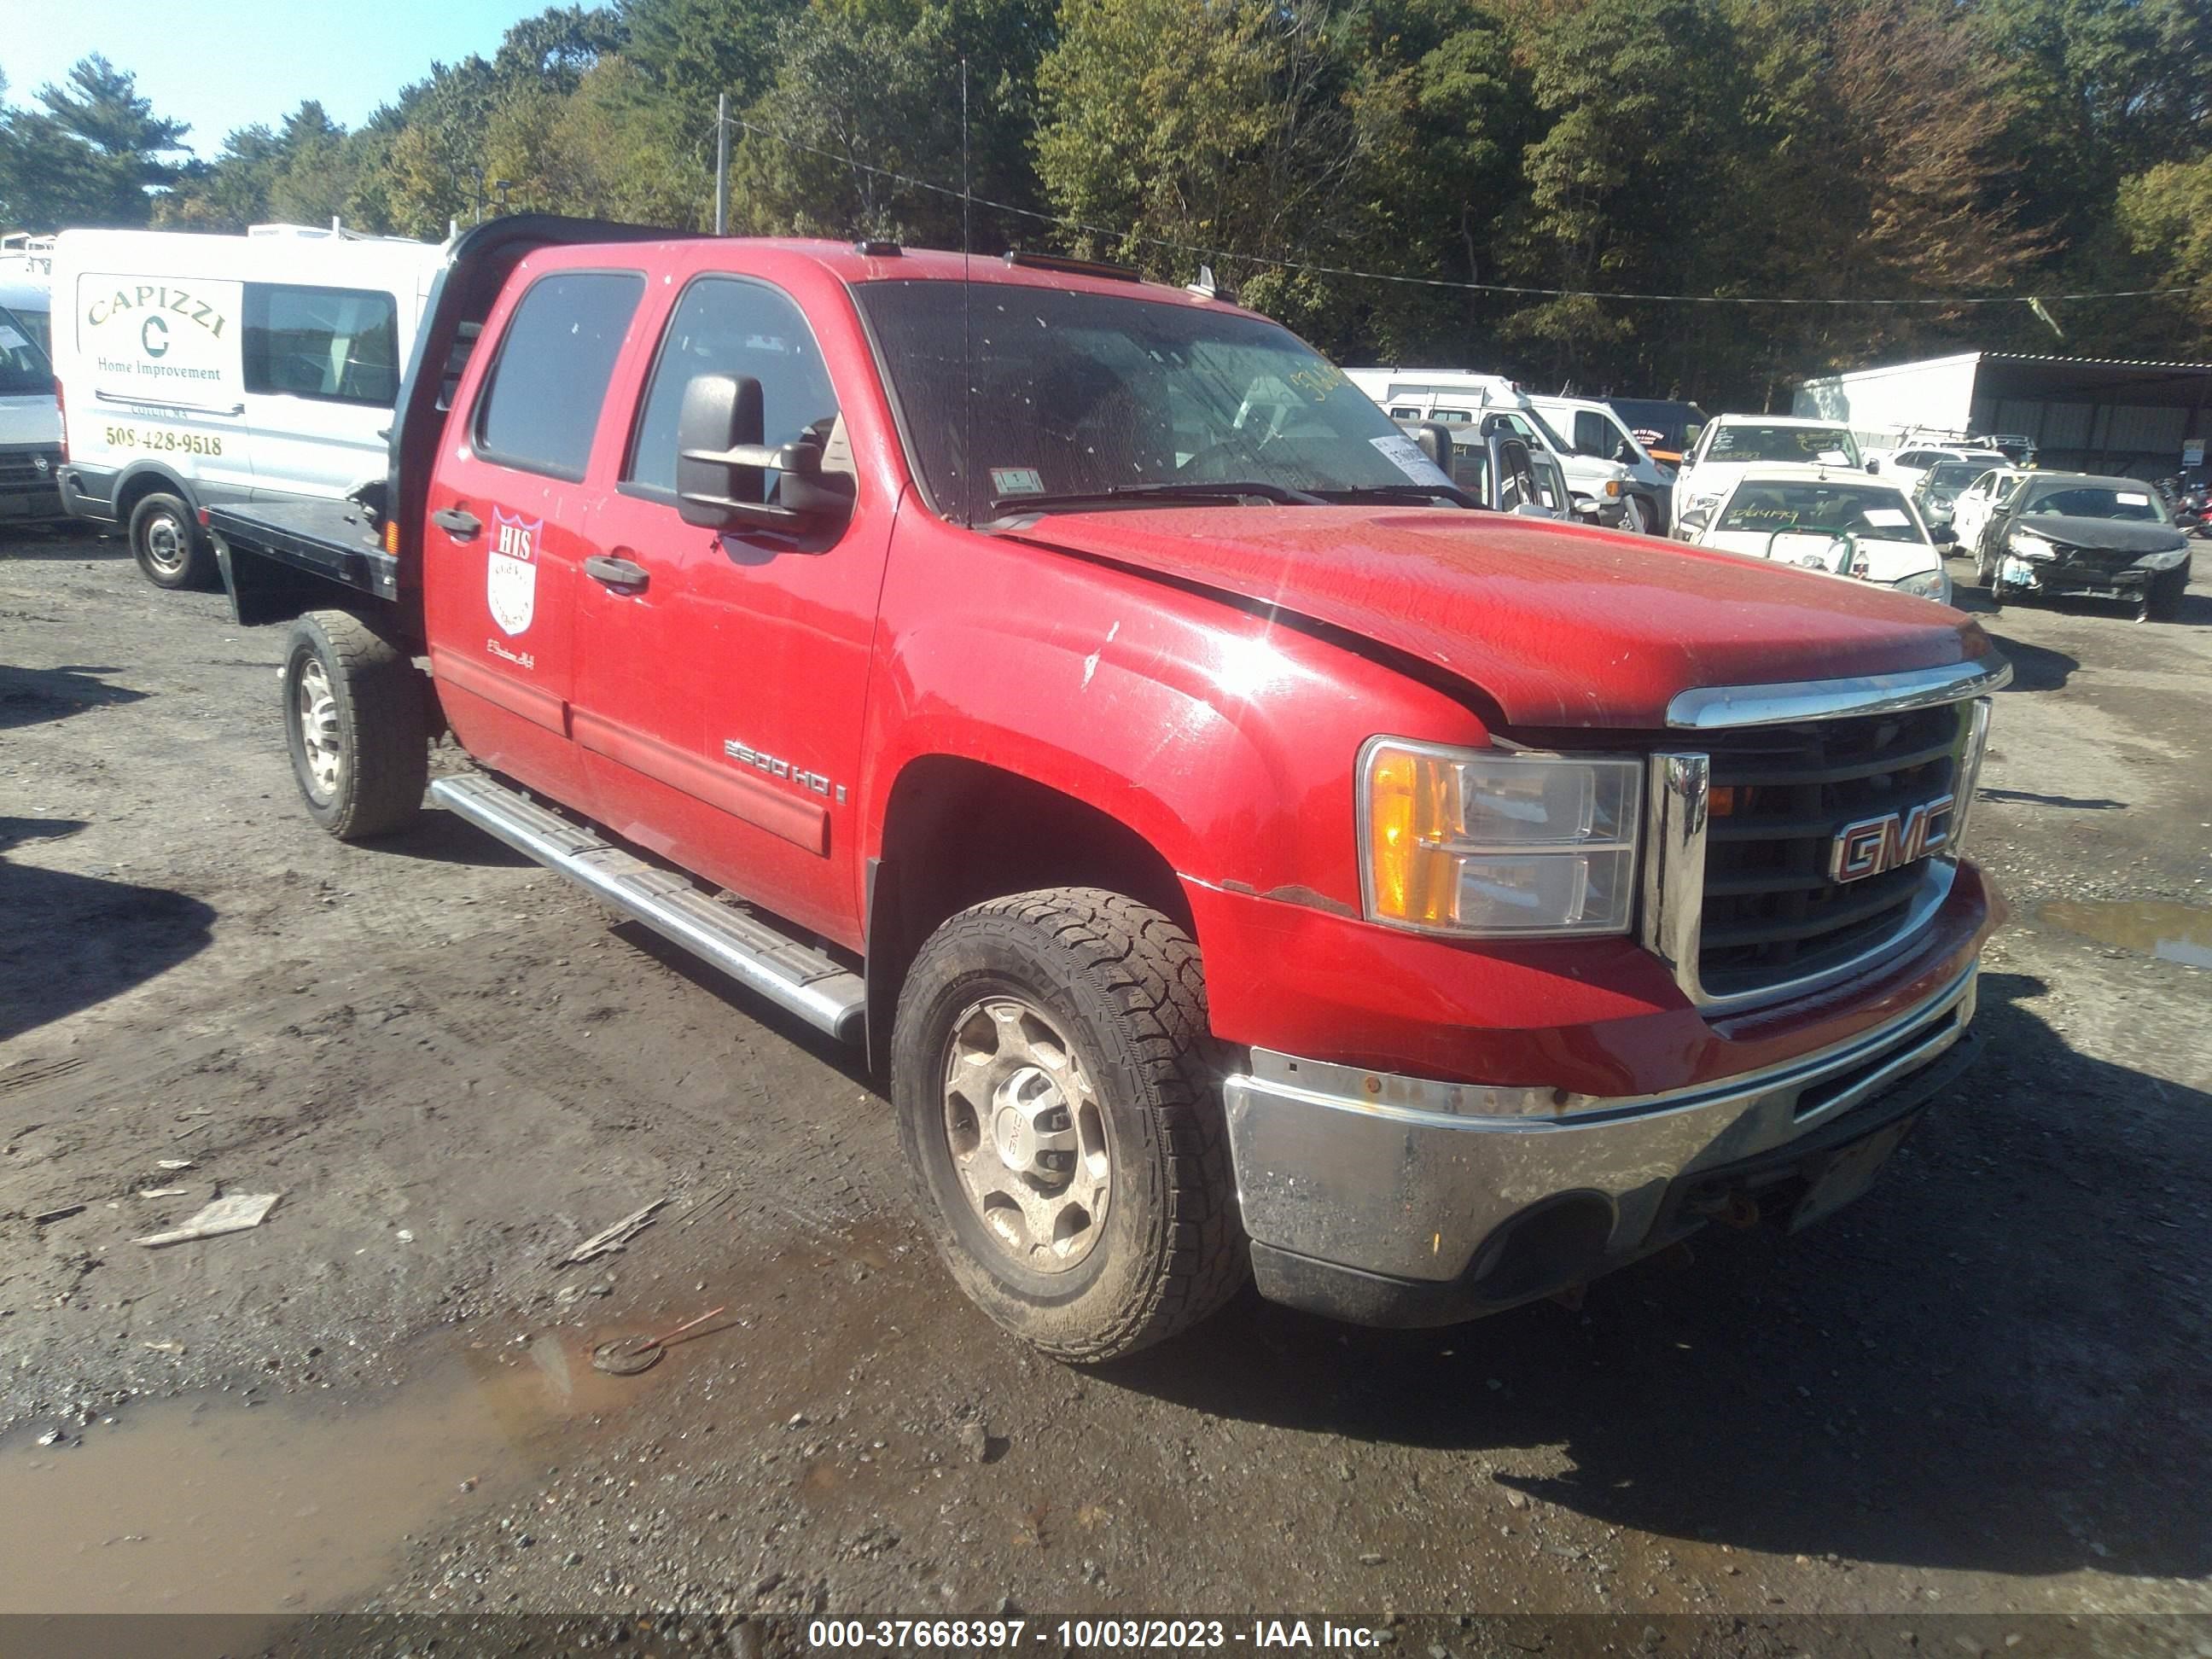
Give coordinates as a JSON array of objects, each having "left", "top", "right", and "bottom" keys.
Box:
[{"left": 1976, "top": 474, "right": 2190, "bottom": 621}]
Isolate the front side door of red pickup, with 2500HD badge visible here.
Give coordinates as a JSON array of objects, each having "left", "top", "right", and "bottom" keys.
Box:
[{"left": 575, "top": 272, "right": 894, "bottom": 945}]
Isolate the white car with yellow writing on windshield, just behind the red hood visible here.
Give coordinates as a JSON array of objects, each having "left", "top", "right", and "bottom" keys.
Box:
[{"left": 1684, "top": 467, "right": 1951, "bottom": 604}]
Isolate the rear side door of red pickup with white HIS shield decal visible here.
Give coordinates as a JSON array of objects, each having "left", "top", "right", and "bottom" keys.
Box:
[{"left": 422, "top": 270, "right": 646, "bottom": 810}]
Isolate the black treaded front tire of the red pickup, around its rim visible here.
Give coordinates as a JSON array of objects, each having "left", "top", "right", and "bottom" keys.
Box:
[{"left": 892, "top": 887, "right": 1252, "bottom": 1363}]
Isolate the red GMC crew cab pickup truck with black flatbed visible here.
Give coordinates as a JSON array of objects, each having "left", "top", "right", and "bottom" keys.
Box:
[{"left": 208, "top": 217, "right": 2009, "bottom": 1360}]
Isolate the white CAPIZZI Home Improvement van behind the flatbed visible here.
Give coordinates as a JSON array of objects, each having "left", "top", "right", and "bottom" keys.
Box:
[{"left": 53, "top": 225, "right": 445, "bottom": 588}]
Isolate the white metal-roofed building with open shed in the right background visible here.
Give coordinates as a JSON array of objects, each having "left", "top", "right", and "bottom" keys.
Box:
[{"left": 1792, "top": 352, "right": 2212, "bottom": 478}]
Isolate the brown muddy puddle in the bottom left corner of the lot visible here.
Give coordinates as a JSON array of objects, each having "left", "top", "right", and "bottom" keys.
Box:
[{"left": 0, "top": 1331, "right": 650, "bottom": 1615}]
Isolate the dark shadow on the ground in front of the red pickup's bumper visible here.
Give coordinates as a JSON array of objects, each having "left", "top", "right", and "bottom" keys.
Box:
[{"left": 1102, "top": 975, "right": 2212, "bottom": 1577}]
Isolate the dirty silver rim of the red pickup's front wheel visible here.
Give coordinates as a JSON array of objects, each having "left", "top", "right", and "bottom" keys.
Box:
[{"left": 945, "top": 995, "right": 1113, "bottom": 1274}]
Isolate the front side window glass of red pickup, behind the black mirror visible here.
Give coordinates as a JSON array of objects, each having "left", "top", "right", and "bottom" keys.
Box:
[{"left": 621, "top": 276, "right": 836, "bottom": 500}]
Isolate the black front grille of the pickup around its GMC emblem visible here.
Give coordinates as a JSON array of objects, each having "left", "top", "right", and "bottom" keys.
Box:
[{"left": 1697, "top": 703, "right": 1970, "bottom": 998}]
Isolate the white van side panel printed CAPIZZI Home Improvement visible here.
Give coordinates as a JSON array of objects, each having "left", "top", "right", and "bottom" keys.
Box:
[{"left": 75, "top": 272, "right": 254, "bottom": 502}]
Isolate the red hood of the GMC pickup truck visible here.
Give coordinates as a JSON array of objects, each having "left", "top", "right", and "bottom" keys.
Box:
[{"left": 1011, "top": 507, "right": 1988, "bottom": 728}]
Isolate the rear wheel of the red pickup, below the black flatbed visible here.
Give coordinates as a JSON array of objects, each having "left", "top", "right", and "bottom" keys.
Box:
[{"left": 283, "top": 610, "right": 429, "bottom": 841}]
